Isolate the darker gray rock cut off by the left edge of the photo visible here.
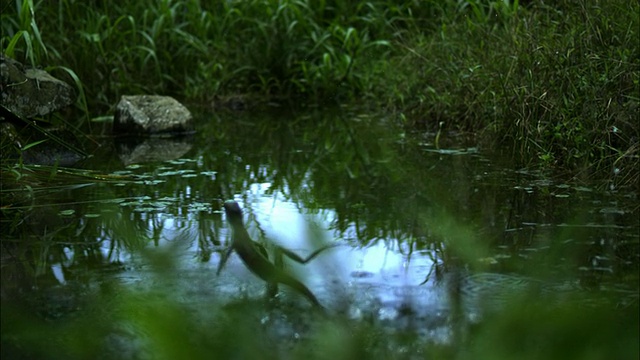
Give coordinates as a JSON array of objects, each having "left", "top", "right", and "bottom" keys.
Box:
[{"left": 0, "top": 55, "right": 76, "bottom": 118}]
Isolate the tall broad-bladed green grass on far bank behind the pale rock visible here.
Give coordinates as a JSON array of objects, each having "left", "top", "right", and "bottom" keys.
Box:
[{"left": 5, "top": 0, "right": 403, "bottom": 107}]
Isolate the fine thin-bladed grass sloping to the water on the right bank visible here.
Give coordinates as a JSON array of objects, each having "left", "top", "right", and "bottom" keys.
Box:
[{"left": 388, "top": 1, "right": 640, "bottom": 184}]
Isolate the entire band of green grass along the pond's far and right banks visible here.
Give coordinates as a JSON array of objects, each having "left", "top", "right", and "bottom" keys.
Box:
[{"left": 2, "top": 0, "right": 640, "bottom": 184}]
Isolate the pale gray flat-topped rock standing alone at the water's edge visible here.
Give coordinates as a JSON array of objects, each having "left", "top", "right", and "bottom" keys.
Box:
[{"left": 113, "top": 95, "right": 193, "bottom": 135}]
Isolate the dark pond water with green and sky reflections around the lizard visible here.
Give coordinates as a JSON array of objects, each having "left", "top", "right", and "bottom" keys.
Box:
[{"left": 2, "top": 109, "right": 640, "bottom": 359}]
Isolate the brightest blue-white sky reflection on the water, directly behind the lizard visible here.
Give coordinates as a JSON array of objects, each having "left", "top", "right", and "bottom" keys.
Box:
[{"left": 209, "top": 184, "right": 442, "bottom": 311}]
